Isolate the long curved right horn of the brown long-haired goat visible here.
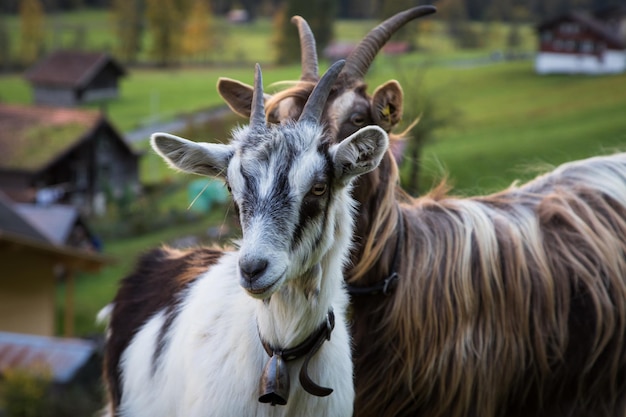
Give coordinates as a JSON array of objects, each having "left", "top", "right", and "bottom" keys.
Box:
[{"left": 341, "top": 6, "right": 437, "bottom": 81}]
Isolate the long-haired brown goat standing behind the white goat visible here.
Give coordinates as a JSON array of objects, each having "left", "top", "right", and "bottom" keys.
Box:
[{"left": 214, "top": 9, "right": 626, "bottom": 417}]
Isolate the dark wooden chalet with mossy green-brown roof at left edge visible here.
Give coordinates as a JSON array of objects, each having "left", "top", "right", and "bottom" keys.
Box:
[{"left": 0, "top": 104, "right": 139, "bottom": 215}]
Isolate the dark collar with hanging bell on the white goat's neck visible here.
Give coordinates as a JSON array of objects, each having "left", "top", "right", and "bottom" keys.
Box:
[{"left": 259, "top": 309, "right": 335, "bottom": 405}]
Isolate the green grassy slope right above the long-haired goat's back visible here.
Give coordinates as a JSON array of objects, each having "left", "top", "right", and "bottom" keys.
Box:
[{"left": 410, "top": 62, "right": 626, "bottom": 194}]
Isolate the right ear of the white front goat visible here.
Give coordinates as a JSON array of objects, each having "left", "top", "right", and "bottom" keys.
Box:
[{"left": 330, "top": 126, "right": 389, "bottom": 183}]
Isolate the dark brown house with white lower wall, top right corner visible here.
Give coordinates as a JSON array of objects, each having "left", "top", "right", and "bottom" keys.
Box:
[{"left": 535, "top": 11, "right": 626, "bottom": 74}]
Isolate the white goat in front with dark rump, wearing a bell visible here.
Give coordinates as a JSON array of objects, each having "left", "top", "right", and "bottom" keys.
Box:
[{"left": 99, "top": 62, "right": 388, "bottom": 417}]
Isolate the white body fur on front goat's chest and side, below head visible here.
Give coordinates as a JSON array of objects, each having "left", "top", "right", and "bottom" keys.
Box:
[{"left": 115, "top": 249, "right": 354, "bottom": 417}]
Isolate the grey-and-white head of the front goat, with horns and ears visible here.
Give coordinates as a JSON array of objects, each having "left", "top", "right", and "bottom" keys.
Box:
[{"left": 152, "top": 62, "right": 388, "bottom": 299}]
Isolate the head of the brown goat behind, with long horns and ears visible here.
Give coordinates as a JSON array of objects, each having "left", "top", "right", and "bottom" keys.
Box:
[{"left": 217, "top": 6, "right": 436, "bottom": 140}]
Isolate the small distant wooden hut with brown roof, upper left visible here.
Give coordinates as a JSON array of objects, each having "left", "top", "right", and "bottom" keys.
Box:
[{"left": 25, "top": 51, "right": 126, "bottom": 106}]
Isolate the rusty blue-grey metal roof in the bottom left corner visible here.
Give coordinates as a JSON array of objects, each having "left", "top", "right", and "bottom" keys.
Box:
[{"left": 0, "top": 332, "right": 96, "bottom": 384}]
